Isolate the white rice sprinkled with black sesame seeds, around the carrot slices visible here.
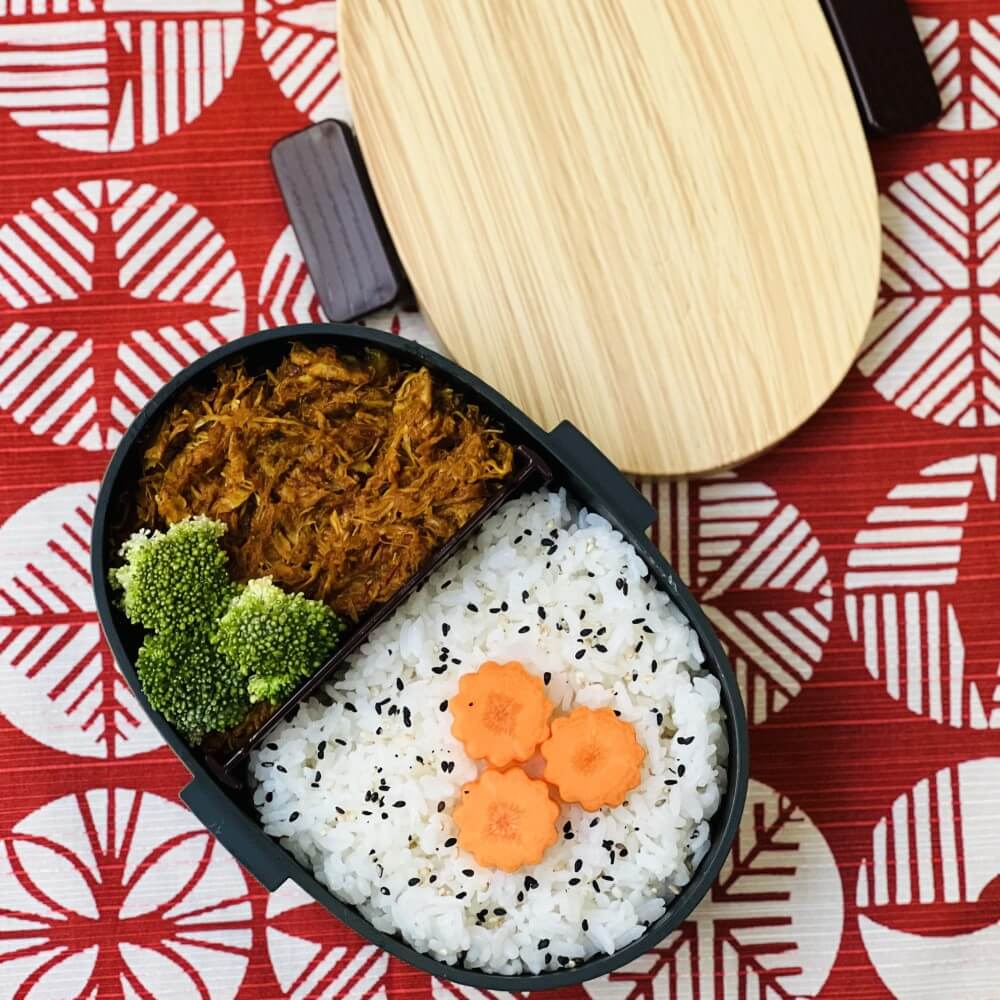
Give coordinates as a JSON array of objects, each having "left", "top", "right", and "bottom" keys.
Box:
[{"left": 250, "top": 491, "right": 727, "bottom": 974}]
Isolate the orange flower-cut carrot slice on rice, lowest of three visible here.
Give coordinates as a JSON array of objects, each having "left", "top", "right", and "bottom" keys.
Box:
[{"left": 452, "top": 767, "right": 559, "bottom": 872}]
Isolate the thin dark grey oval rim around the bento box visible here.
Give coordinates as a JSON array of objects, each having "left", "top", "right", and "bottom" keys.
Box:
[{"left": 91, "top": 323, "right": 749, "bottom": 992}]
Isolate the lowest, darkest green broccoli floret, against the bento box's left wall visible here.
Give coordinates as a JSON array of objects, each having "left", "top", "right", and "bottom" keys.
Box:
[{"left": 136, "top": 630, "right": 250, "bottom": 744}]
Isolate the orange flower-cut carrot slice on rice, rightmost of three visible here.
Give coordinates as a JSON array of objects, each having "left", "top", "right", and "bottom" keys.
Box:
[{"left": 542, "top": 708, "right": 646, "bottom": 809}]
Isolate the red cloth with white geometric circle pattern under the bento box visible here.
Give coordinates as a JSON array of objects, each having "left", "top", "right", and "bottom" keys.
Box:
[{"left": 0, "top": 0, "right": 1000, "bottom": 1000}]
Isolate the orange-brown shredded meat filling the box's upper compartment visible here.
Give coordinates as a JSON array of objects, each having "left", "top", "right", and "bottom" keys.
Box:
[{"left": 137, "top": 344, "right": 513, "bottom": 619}]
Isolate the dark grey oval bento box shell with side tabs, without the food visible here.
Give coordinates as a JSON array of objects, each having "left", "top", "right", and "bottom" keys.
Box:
[{"left": 91, "top": 325, "right": 749, "bottom": 992}]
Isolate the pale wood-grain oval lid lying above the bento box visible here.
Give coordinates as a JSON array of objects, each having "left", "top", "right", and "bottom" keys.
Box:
[{"left": 341, "top": 0, "right": 879, "bottom": 474}]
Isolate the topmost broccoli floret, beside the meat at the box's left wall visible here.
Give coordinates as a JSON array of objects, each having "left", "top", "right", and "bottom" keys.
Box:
[{"left": 109, "top": 517, "right": 236, "bottom": 635}]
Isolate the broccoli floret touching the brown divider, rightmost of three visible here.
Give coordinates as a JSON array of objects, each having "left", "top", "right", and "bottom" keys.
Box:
[{"left": 216, "top": 577, "right": 344, "bottom": 702}]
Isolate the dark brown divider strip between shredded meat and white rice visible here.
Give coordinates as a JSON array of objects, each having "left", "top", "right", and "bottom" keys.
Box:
[{"left": 216, "top": 445, "right": 552, "bottom": 788}]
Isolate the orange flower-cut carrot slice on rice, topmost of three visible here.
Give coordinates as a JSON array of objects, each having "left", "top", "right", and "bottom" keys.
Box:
[{"left": 450, "top": 661, "right": 553, "bottom": 767}]
